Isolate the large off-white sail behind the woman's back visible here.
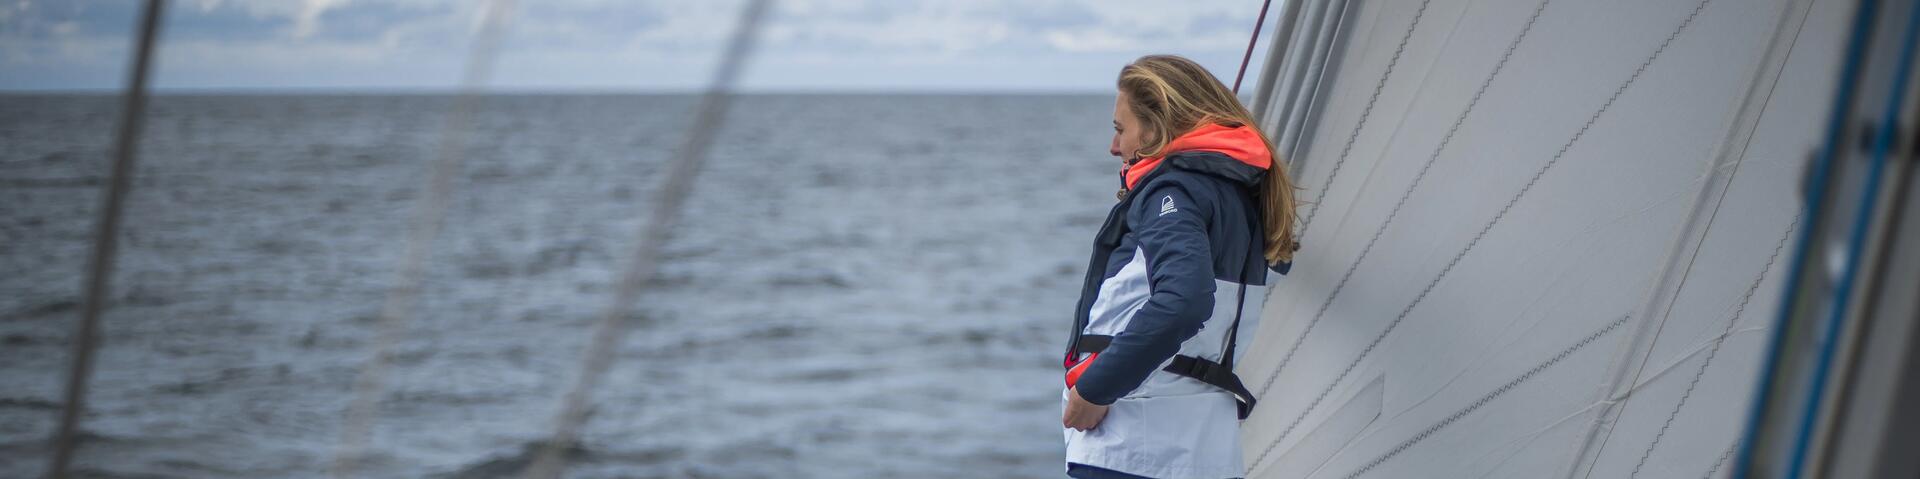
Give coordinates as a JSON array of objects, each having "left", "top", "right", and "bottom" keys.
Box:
[{"left": 1238, "top": 0, "right": 1853, "bottom": 477}]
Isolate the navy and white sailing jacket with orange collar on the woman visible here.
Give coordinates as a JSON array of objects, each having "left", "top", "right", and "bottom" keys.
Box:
[{"left": 1062, "top": 127, "right": 1284, "bottom": 479}]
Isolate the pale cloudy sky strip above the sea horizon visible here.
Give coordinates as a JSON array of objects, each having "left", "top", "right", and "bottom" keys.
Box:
[{"left": 0, "top": 0, "right": 1284, "bottom": 92}]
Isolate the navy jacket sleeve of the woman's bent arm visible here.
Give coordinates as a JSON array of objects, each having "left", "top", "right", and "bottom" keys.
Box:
[{"left": 1075, "top": 183, "right": 1213, "bottom": 404}]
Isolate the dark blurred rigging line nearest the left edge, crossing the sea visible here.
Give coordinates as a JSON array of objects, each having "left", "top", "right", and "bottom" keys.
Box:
[{"left": 46, "top": 0, "right": 167, "bottom": 477}]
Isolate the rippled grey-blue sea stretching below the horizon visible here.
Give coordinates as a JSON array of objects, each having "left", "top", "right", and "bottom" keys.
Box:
[{"left": 0, "top": 94, "right": 1119, "bottom": 477}]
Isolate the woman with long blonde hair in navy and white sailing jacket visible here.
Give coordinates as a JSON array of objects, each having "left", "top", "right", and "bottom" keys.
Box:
[{"left": 1062, "top": 56, "right": 1296, "bottom": 479}]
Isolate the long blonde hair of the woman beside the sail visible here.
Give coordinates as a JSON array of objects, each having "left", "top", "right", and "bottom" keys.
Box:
[{"left": 1119, "top": 56, "right": 1300, "bottom": 264}]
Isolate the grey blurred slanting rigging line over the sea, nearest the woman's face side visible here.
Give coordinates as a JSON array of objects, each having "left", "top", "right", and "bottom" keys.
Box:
[{"left": 526, "top": 0, "right": 770, "bottom": 479}]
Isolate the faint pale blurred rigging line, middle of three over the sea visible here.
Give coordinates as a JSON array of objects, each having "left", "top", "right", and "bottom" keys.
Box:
[{"left": 332, "top": 0, "right": 513, "bottom": 477}]
